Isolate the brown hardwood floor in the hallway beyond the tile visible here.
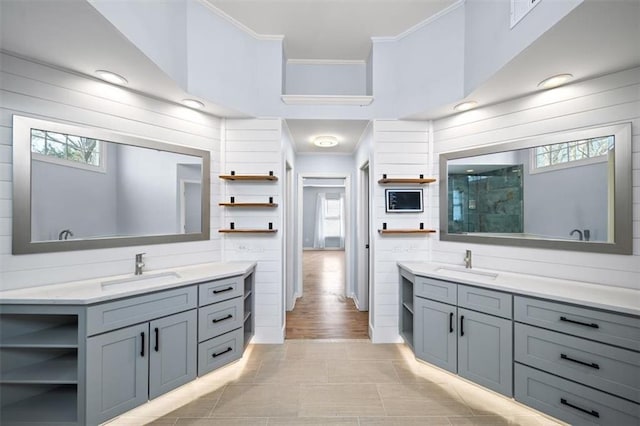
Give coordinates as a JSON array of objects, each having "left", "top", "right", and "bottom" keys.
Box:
[{"left": 286, "top": 250, "right": 369, "bottom": 339}]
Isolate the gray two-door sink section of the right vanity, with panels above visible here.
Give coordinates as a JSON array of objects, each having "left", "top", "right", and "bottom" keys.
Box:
[{"left": 410, "top": 274, "right": 513, "bottom": 396}]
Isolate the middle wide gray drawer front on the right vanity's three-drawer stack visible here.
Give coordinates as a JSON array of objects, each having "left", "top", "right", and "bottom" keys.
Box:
[{"left": 514, "top": 323, "right": 640, "bottom": 402}]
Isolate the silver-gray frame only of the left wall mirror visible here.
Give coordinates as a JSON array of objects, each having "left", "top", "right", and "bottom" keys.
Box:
[{"left": 12, "top": 115, "right": 211, "bottom": 254}]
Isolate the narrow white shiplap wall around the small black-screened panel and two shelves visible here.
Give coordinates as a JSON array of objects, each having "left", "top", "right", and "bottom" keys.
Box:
[{"left": 370, "top": 120, "right": 437, "bottom": 343}]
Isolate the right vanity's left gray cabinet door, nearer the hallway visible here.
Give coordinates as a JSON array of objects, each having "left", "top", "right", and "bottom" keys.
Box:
[{"left": 413, "top": 297, "right": 456, "bottom": 373}]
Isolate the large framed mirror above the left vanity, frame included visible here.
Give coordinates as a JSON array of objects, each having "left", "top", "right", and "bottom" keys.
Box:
[{"left": 12, "top": 115, "right": 210, "bottom": 254}]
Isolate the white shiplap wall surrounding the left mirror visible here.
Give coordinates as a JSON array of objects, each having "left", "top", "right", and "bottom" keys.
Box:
[{"left": 0, "top": 54, "right": 221, "bottom": 290}]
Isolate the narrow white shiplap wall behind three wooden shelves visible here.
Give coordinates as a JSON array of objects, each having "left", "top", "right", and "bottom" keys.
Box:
[{"left": 221, "top": 119, "right": 285, "bottom": 343}]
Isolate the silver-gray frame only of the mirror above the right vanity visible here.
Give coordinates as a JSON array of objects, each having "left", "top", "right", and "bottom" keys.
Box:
[{"left": 439, "top": 123, "right": 633, "bottom": 254}]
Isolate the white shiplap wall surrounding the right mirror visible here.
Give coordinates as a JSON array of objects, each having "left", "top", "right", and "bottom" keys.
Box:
[{"left": 429, "top": 68, "right": 640, "bottom": 289}]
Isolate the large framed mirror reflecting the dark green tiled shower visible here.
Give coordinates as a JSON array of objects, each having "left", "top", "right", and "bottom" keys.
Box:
[{"left": 440, "top": 123, "right": 632, "bottom": 254}]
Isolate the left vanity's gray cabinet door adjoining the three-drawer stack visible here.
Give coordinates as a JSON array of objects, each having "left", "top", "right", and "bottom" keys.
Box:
[{"left": 149, "top": 309, "right": 198, "bottom": 398}]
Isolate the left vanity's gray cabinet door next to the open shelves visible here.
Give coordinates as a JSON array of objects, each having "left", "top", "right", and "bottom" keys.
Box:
[{"left": 86, "top": 323, "right": 149, "bottom": 425}]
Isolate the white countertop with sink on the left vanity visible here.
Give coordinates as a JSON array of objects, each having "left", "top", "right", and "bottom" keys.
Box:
[{"left": 0, "top": 262, "right": 256, "bottom": 305}]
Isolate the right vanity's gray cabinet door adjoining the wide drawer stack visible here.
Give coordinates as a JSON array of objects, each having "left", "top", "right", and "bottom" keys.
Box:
[{"left": 458, "top": 308, "right": 513, "bottom": 396}]
